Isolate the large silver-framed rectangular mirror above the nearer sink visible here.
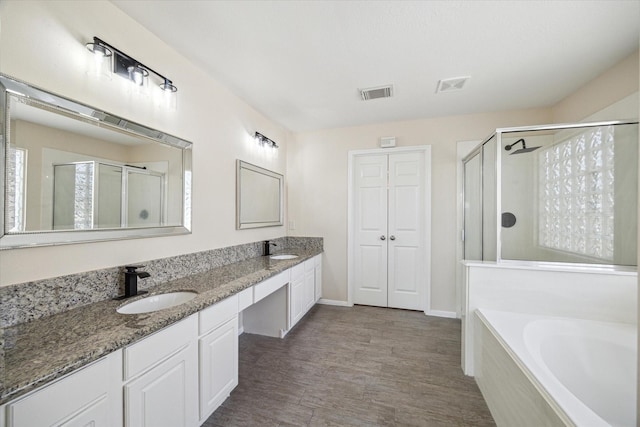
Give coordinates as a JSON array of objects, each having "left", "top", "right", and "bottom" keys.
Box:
[{"left": 0, "top": 75, "right": 192, "bottom": 249}]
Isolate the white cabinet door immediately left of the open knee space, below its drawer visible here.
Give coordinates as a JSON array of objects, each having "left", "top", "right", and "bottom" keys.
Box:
[{"left": 198, "top": 316, "right": 238, "bottom": 422}]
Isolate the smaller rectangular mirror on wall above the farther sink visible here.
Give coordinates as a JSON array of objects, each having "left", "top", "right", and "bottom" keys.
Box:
[{"left": 236, "top": 160, "right": 284, "bottom": 230}]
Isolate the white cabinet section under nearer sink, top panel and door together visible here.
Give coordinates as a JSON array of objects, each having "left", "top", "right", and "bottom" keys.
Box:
[{"left": 123, "top": 314, "right": 199, "bottom": 427}]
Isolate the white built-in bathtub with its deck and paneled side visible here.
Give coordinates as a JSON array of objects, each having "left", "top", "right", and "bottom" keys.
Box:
[{"left": 474, "top": 309, "right": 637, "bottom": 427}]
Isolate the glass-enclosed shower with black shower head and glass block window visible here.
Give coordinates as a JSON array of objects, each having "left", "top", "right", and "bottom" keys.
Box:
[{"left": 463, "top": 121, "right": 638, "bottom": 266}]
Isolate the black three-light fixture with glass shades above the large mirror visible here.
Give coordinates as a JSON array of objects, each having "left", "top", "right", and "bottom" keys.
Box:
[{"left": 86, "top": 37, "right": 178, "bottom": 98}]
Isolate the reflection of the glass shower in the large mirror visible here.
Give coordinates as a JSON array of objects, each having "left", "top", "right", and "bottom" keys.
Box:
[{"left": 53, "top": 161, "right": 166, "bottom": 230}]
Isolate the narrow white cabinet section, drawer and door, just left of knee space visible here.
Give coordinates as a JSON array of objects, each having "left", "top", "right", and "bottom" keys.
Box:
[{"left": 198, "top": 295, "right": 239, "bottom": 423}]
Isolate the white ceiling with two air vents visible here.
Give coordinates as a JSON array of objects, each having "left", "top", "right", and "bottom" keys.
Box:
[{"left": 113, "top": 0, "right": 640, "bottom": 131}]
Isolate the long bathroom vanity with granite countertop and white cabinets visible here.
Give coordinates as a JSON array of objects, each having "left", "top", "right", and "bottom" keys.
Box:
[{"left": 0, "top": 250, "right": 322, "bottom": 427}]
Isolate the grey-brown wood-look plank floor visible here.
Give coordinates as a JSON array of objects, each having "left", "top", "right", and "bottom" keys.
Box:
[{"left": 204, "top": 305, "right": 495, "bottom": 427}]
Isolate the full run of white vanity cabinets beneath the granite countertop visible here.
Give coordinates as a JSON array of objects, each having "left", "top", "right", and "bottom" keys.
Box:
[{"left": 0, "top": 255, "right": 322, "bottom": 427}]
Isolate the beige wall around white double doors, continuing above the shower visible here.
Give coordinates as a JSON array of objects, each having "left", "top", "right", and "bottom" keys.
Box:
[{"left": 287, "top": 52, "right": 638, "bottom": 312}]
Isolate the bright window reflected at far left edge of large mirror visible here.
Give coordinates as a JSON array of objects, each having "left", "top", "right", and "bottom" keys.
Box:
[{"left": 5, "top": 146, "right": 27, "bottom": 232}]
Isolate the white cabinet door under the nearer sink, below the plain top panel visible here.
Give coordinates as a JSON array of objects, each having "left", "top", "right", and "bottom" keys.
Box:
[{"left": 124, "top": 342, "right": 198, "bottom": 427}]
